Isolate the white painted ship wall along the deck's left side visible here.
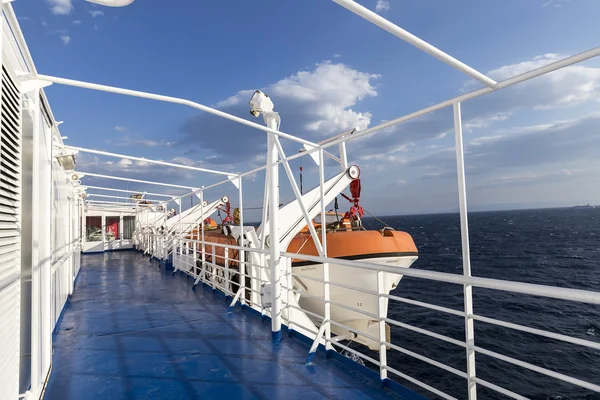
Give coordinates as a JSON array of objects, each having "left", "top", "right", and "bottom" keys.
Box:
[{"left": 0, "top": 4, "right": 81, "bottom": 399}]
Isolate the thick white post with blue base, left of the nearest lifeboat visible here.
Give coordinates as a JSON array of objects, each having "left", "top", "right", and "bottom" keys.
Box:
[{"left": 264, "top": 112, "right": 281, "bottom": 342}]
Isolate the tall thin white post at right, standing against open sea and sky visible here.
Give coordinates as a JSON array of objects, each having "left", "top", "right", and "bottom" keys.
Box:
[{"left": 453, "top": 103, "right": 477, "bottom": 400}]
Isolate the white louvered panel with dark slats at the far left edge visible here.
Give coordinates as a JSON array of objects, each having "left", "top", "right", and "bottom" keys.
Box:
[{"left": 0, "top": 62, "right": 22, "bottom": 399}]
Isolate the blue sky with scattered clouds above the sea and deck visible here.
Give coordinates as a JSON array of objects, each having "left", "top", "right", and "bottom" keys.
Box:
[{"left": 13, "top": 0, "right": 600, "bottom": 219}]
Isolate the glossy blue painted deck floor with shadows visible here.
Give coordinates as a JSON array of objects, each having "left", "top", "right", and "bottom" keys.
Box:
[{"left": 44, "top": 252, "right": 414, "bottom": 400}]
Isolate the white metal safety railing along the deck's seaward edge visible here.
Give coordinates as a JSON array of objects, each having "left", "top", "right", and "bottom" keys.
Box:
[{"left": 134, "top": 235, "right": 600, "bottom": 399}]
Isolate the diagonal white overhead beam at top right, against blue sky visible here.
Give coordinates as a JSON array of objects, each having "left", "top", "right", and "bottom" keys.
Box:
[{"left": 333, "top": 0, "right": 496, "bottom": 87}]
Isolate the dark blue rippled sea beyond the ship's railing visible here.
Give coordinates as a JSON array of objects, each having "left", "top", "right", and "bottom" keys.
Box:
[{"left": 362, "top": 208, "right": 600, "bottom": 400}]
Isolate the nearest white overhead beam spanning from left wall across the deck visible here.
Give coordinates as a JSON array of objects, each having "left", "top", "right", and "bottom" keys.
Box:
[{"left": 37, "top": 74, "right": 315, "bottom": 146}]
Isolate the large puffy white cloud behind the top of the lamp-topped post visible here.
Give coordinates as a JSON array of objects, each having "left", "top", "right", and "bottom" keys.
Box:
[{"left": 182, "top": 62, "right": 379, "bottom": 163}]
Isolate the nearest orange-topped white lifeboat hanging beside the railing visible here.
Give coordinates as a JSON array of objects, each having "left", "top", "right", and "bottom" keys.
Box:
[{"left": 289, "top": 230, "right": 418, "bottom": 350}]
